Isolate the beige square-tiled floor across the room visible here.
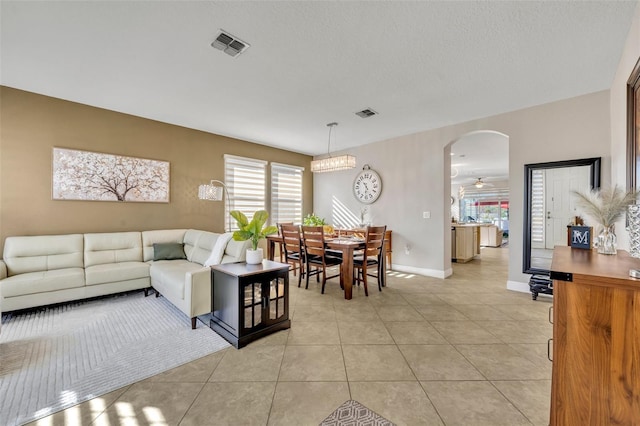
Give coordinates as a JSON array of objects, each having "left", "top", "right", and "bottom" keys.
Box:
[{"left": 34, "top": 248, "right": 552, "bottom": 426}]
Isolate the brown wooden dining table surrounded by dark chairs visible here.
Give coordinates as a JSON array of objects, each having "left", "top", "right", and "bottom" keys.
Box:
[{"left": 267, "top": 234, "right": 386, "bottom": 300}]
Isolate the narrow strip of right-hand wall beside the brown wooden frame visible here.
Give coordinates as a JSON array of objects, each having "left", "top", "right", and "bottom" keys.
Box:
[{"left": 611, "top": 4, "right": 640, "bottom": 250}]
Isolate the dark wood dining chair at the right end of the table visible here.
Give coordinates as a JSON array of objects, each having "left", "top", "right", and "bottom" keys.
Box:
[{"left": 353, "top": 226, "right": 387, "bottom": 296}]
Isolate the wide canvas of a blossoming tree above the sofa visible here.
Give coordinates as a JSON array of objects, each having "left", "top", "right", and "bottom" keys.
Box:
[{"left": 53, "top": 148, "right": 169, "bottom": 203}]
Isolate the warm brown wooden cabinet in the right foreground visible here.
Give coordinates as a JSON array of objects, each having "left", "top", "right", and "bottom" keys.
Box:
[{"left": 550, "top": 246, "right": 640, "bottom": 426}]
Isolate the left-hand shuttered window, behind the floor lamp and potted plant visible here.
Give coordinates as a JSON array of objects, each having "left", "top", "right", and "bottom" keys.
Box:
[{"left": 224, "top": 155, "right": 267, "bottom": 230}]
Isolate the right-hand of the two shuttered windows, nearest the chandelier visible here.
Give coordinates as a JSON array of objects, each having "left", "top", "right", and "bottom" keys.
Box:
[{"left": 271, "top": 163, "right": 304, "bottom": 225}]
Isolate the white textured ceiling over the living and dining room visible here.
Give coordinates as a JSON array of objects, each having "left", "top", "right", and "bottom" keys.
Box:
[{"left": 0, "top": 1, "right": 637, "bottom": 155}]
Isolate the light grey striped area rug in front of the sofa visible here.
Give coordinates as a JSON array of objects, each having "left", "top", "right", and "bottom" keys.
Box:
[{"left": 0, "top": 292, "right": 230, "bottom": 426}]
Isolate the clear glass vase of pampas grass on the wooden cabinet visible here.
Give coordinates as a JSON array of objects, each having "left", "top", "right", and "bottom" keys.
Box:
[{"left": 573, "top": 185, "right": 638, "bottom": 254}]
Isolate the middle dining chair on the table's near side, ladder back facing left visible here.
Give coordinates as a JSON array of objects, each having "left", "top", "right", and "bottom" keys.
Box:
[{"left": 302, "top": 226, "right": 344, "bottom": 294}]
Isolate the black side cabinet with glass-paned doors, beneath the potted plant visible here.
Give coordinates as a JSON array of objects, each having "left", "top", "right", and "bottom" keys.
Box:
[{"left": 210, "top": 260, "right": 291, "bottom": 349}]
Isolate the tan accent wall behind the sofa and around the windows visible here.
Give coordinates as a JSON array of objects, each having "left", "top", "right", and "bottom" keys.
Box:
[{"left": 0, "top": 87, "right": 313, "bottom": 253}]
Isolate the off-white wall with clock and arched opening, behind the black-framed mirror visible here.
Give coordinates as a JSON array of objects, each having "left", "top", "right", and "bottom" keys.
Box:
[{"left": 314, "top": 91, "right": 611, "bottom": 289}]
